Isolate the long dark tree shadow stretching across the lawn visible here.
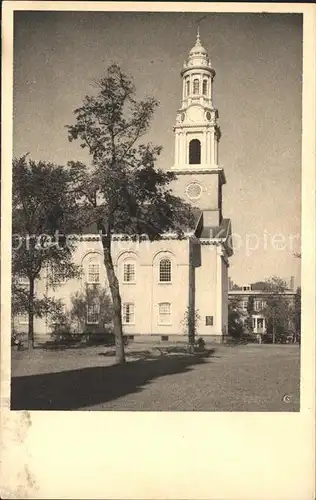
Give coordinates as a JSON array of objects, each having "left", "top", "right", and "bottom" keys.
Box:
[{"left": 11, "top": 353, "right": 215, "bottom": 410}]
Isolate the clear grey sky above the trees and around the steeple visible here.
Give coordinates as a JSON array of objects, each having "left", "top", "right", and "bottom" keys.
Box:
[{"left": 13, "top": 11, "right": 302, "bottom": 284}]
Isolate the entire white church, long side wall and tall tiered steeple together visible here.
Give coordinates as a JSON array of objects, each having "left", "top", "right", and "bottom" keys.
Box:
[{"left": 15, "top": 33, "right": 233, "bottom": 342}]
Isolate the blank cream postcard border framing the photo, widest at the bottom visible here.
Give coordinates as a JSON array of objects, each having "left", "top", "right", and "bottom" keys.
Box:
[{"left": 0, "top": 1, "right": 316, "bottom": 500}]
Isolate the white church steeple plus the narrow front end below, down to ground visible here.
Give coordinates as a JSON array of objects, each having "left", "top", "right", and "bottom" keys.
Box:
[{"left": 170, "top": 30, "right": 233, "bottom": 342}]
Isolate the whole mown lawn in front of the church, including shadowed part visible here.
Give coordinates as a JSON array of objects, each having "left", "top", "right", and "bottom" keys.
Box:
[{"left": 11, "top": 343, "right": 300, "bottom": 412}]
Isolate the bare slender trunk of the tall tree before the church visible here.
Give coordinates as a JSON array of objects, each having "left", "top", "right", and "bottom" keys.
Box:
[{"left": 102, "top": 230, "right": 125, "bottom": 364}]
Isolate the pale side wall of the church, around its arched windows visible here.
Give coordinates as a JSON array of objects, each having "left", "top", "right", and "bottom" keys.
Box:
[{"left": 25, "top": 236, "right": 189, "bottom": 335}]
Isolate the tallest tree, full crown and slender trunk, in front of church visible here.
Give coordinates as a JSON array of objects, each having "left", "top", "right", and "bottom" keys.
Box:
[{"left": 67, "top": 65, "right": 193, "bottom": 363}]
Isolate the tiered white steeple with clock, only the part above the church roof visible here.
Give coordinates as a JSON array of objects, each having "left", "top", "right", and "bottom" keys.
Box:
[{"left": 171, "top": 31, "right": 226, "bottom": 227}]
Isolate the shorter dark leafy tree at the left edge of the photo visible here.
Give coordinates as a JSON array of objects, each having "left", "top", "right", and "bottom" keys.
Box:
[{"left": 12, "top": 155, "right": 79, "bottom": 347}]
